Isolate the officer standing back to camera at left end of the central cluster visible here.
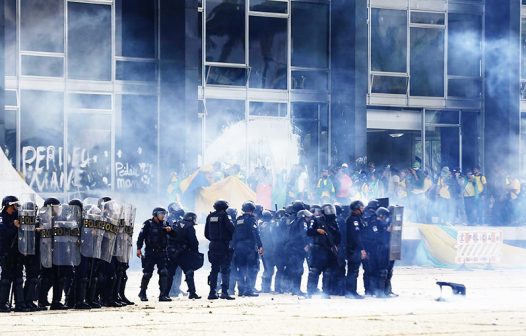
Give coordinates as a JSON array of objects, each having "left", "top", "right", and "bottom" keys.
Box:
[{"left": 205, "top": 200, "right": 234, "bottom": 300}]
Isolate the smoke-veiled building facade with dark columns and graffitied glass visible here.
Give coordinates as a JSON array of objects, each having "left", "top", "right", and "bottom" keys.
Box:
[{"left": 0, "top": 0, "right": 526, "bottom": 198}]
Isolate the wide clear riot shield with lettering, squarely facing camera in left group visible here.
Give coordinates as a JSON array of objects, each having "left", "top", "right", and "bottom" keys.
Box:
[{"left": 53, "top": 205, "right": 82, "bottom": 266}]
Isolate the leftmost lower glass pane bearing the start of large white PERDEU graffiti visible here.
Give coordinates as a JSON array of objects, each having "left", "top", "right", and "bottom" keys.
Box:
[{"left": 20, "top": 90, "right": 65, "bottom": 192}]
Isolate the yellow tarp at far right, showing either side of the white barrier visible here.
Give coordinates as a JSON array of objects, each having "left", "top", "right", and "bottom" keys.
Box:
[{"left": 418, "top": 224, "right": 526, "bottom": 268}]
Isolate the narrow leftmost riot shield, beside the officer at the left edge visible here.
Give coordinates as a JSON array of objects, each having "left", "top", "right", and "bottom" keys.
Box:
[{"left": 18, "top": 194, "right": 38, "bottom": 256}]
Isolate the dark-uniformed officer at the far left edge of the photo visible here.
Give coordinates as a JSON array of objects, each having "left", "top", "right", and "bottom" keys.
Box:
[{"left": 0, "top": 196, "right": 29, "bottom": 313}]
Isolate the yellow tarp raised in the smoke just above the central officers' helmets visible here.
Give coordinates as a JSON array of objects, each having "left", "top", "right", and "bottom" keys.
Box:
[{"left": 195, "top": 176, "right": 256, "bottom": 214}]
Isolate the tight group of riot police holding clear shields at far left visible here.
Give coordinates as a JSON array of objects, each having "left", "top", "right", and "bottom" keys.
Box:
[{"left": 0, "top": 195, "right": 136, "bottom": 312}]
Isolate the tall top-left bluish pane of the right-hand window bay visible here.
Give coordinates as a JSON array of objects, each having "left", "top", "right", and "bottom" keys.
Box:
[{"left": 371, "top": 8, "right": 407, "bottom": 73}]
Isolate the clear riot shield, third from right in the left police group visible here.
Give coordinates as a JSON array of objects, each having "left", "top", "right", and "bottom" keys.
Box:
[{"left": 80, "top": 203, "right": 104, "bottom": 259}]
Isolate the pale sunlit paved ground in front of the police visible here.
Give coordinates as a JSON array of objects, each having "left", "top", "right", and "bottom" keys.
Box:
[{"left": 0, "top": 268, "right": 526, "bottom": 336}]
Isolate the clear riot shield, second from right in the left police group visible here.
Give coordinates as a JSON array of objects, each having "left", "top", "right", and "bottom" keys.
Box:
[{"left": 99, "top": 201, "right": 122, "bottom": 262}]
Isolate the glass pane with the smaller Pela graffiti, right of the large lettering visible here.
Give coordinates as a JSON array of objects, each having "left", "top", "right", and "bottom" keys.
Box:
[{"left": 115, "top": 95, "right": 158, "bottom": 192}]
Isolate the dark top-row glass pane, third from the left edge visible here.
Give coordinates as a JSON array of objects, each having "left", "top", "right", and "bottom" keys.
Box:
[{"left": 115, "top": 0, "right": 156, "bottom": 58}]
